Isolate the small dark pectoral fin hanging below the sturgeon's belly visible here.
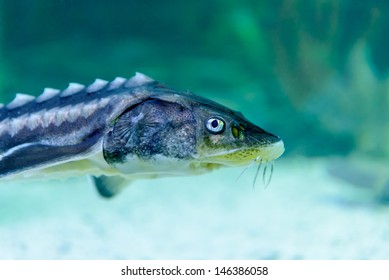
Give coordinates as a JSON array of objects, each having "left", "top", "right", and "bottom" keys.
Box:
[{"left": 92, "top": 175, "right": 128, "bottom": 198}]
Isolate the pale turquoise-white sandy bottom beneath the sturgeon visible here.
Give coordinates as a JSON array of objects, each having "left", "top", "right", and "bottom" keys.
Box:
[{"left": 0, "top": 158, "right": 389, "bottom": 259}]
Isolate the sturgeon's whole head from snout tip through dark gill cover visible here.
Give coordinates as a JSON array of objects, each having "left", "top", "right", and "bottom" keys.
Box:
[{"left": 103, "top": 89, "right": 284, "bottom": 177}]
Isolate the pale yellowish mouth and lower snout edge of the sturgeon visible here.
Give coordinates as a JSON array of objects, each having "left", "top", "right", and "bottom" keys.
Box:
[{"left": 202, "top": 140, "right": 285, "bottom": 166}]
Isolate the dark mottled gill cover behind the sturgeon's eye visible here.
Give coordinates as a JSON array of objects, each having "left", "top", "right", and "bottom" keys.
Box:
[{"left": 103, "top": 99, "right": 196, "bottom": 167}]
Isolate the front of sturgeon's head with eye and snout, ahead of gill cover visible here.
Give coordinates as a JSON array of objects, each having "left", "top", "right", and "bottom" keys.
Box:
[{"left": 189, "top": 95, "right": 284, "bottom": 168}]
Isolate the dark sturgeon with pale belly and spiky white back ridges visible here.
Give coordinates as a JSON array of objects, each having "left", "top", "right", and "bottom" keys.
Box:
[{"left": 0, "top": 72, "right": 284, "bottom": 198}]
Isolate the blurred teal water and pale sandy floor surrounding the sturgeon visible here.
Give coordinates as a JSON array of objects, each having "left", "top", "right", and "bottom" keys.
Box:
[{"left": 0, "top": 0, "right": 389, "bottom": 259}]
